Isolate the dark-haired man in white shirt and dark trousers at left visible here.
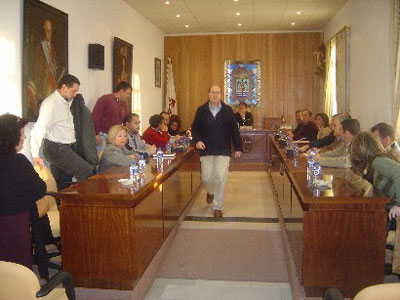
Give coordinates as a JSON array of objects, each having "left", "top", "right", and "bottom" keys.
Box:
[{"left": 31, "top": 74, "right": 93, "bottom": 189}]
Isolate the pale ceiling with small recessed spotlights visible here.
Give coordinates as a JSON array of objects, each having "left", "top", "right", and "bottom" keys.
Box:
[{"left": 125, "top": 0, "right": 348, "bottom": 34}]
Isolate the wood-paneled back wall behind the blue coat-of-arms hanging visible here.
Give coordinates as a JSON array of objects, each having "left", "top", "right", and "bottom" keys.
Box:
[{"left": 164, "top": 32, "right": 324, "bottom": 128}]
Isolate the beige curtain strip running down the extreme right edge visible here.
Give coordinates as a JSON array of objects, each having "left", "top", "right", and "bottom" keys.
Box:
[{"left": 389, "top": 0, "right": 400, "bottom": 140}]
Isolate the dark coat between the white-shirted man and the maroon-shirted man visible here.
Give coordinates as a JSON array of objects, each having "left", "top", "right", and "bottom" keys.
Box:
[{"left": 71, "top": 94, "right": 97, "bottom": 166}]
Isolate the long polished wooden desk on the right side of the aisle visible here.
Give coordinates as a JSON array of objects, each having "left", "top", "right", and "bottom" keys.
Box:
[{"left": 270, "top": 139, "right": 389, "bottom": 297}]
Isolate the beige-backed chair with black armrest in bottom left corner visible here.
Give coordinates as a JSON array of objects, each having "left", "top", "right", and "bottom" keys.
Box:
[{"left": 0, "top": 261, "right": 76, "bottom": 300}]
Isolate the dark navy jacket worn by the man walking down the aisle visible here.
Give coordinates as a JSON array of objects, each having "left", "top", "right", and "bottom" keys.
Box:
[{"left": 192, "top": 101, "right": 243, "bottom": 156}]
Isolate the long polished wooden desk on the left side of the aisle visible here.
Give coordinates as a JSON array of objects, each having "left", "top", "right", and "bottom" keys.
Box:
[{"left": 57, "top": 150, "right": 200, "bottom": 289}]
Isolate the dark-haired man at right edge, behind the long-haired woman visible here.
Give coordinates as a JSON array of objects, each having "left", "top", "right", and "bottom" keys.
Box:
[{"left": 371, "top": 122, "right": 400, "bottom": 162}]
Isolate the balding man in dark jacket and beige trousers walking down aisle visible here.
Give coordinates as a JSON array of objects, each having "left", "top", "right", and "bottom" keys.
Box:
[{"left": 192, "top": 86, "right": 243, "bottom": 218}]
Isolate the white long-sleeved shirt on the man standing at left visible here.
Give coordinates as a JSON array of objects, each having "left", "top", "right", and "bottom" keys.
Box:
[{"left": 31, "top": 90, "right": 76, "bottom": 157}]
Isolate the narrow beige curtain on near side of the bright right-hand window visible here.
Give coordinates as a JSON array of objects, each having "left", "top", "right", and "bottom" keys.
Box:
[{"left": 335, "top": 27, "right": 349, "bottom": 113}]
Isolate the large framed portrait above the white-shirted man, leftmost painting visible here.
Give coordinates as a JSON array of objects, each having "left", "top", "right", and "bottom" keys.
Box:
[{"left": 22, "top": 0, "right": 68, "bottom": 121}]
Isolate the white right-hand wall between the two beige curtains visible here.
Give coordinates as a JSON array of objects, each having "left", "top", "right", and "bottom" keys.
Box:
[{"left": 324, "top": 0, "right": 390, "bottom": 130}]
